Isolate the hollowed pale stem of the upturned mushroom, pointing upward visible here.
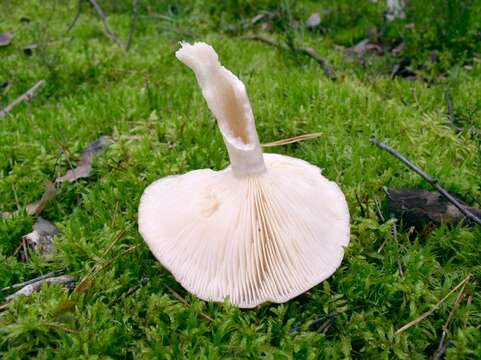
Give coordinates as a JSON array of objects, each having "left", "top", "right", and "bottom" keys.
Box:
[{"left": 175, "top": 42, "right": 266, "bottom": 177}]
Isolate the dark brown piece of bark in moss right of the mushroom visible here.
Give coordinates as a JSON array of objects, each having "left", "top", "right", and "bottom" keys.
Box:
[{"left": 388, "top": 189, "right": 481, "bottom": 229}]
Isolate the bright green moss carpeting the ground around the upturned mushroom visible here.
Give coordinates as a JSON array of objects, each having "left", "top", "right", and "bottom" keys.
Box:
[{"left": 0, "top": 1, "right": 481, "bottom": 359}]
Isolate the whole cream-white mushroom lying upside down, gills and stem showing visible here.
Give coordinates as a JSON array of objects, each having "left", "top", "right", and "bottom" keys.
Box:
[{"left": 139, "top": 42, "right": 349, "bottom": 308}]
